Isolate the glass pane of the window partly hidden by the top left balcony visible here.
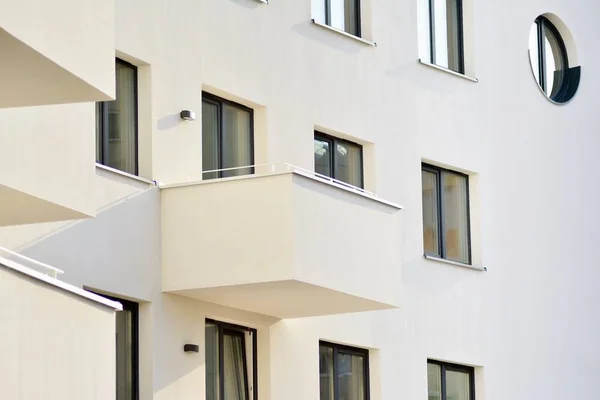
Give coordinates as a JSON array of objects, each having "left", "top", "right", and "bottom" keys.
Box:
[{"left": 104, "top": 63, "right": 137, "bottom": 174}]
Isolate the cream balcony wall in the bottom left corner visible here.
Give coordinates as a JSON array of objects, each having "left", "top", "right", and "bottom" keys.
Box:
[{"left": 0, "top": 265, "right": 116, "bottom": 400}]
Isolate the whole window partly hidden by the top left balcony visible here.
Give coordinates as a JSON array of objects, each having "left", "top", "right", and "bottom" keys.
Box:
[{"left": 96, "top": 59, "right": 138, "bottom": 175}]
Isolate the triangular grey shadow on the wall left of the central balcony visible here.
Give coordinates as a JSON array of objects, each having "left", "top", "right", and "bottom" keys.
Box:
[{"left": 2, "top": 187, "right": 161, "bottom": 300}]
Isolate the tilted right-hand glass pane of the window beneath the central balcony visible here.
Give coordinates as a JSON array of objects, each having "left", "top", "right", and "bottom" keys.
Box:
[{"left": 223, "top": 333, "right": 247, "bottom": 400}]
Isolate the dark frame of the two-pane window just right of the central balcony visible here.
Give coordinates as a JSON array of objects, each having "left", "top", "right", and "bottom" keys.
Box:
[{"left": 421, "top": 163, "right": 473, "bottom": 265}]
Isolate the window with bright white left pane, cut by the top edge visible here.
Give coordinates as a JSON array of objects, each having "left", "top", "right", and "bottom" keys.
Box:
[{"left": 429, "top": 0, "right": 465, "bottom": 74}]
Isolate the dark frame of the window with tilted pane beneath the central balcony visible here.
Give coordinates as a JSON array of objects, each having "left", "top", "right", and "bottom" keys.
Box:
[{"left": 204, "top": 318, "right": 258, "bottom": 400}]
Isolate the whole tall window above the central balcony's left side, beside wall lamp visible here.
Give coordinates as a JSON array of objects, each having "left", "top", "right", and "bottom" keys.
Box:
[{"left": 202, "top": 93, "right": 254, "bottom": 179}]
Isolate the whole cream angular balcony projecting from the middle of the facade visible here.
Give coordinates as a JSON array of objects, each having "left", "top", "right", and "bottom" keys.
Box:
[{"left": 161, "top": 164, "right": 402, "bottom": 318}]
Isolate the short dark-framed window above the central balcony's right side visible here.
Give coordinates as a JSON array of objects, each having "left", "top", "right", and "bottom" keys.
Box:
[{"left": 314, "top": 132, "right": 363, "bottom": 188}]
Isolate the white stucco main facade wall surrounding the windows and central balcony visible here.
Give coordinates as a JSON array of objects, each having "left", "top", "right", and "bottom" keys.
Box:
[{"left": 0, "top": 0, "right": 600, "bottom": 400}]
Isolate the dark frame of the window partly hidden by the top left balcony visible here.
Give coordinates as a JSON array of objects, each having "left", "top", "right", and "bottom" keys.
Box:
[{"left": 96, "top": 58, "right": 139, "bottom": 175}]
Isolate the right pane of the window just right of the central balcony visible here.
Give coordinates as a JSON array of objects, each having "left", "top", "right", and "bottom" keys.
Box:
[{"left": 442, "top": 171, "right": 469, "bottom": 263}]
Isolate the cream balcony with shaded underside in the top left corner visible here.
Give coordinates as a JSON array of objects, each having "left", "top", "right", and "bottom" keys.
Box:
[{"left": 0, "top": 0, "right": 115, "bottom": 108}]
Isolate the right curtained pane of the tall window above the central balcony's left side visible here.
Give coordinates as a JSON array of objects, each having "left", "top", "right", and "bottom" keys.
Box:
[{"left": 221, "top": 104, "right": 253, "bottom": 177}]
